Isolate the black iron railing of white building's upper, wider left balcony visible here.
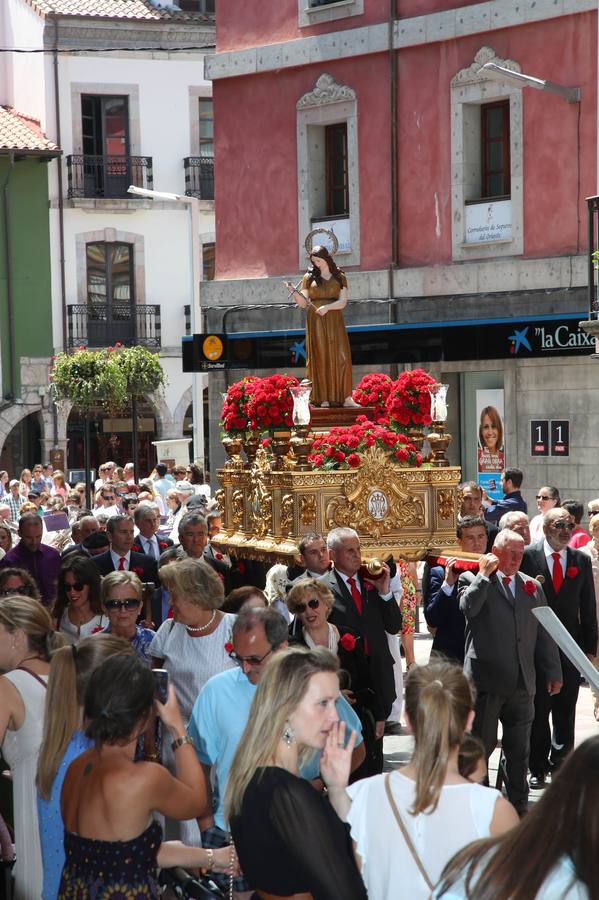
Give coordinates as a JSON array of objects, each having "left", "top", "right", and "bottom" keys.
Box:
[{"left": 67, "top": 154, "right": 154, "bottom": 200}]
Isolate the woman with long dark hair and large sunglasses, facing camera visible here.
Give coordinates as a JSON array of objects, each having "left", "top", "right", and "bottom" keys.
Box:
[{"left": 53, "top": 554, "right": 108, "bottom": 644}]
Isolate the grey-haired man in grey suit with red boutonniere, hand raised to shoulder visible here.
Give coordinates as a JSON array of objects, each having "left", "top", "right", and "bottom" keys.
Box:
[{"left": 458, "top": 529, "right": 562, "bottom": 815}]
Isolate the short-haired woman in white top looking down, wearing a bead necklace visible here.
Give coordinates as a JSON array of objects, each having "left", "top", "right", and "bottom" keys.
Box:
[{"left": 148, "top": 557, "right": 235, "bottom": 846}]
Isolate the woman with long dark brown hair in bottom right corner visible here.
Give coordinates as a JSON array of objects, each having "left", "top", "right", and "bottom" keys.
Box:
[{"left": 434, "top": 737, "right": 599, "bottom": 900}]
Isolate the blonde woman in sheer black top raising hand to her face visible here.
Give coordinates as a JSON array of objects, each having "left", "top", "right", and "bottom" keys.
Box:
[{"left": 225, "top": 647, "right": 366, "bottom": 900}]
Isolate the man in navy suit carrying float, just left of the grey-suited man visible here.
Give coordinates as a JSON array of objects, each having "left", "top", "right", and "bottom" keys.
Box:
[{"left": 422, "top": 515, "right": 487, "bottom": 665}]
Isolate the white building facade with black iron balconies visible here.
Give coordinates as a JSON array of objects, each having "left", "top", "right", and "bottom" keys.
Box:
[{"left": 2, "top": 0, "right": 214, "bottom": 472}]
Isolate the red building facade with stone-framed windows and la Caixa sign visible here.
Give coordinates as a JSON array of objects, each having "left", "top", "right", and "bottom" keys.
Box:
[{"left": 203, "top": 0, "right": 599, "bottom": 509}]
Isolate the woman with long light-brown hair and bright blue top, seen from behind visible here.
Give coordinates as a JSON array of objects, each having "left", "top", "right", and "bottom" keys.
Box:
[{"left": 37, "top": 634, "right": 132, "bottom": 900}]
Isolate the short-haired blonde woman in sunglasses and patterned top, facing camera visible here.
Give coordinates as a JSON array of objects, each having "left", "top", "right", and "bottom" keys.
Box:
[{"left": 102, "top": 572, "right": 156, "bottom": 666}]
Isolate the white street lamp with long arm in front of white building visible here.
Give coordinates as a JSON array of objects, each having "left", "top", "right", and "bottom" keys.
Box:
[{"left": 127, "top": 184, "right": 204, "bottom": 469}]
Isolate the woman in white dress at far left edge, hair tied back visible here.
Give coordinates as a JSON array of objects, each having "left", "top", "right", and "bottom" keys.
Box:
[{"left": 0, "top": 595, "right": 64, "bottom": 900}]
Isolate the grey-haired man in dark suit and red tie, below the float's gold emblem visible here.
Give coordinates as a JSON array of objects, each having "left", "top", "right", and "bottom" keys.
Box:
[{"left": 321, "top": 528, "right": 401, "bottom": 771}]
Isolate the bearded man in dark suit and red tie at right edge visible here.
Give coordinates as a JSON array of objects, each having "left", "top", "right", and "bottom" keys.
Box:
[{"left": 522, "top": 507, "right": 597, "bottom": 788}]
